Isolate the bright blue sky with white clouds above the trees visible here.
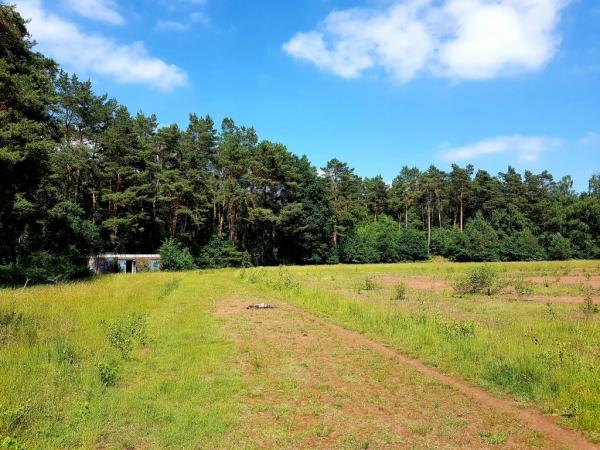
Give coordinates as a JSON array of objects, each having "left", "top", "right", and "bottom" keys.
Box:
[{"left": 13, "top": 0, "right": 600, "bottom": 190}]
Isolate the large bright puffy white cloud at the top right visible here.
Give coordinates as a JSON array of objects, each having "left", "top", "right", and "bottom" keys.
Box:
[{"left": 283, "top": 0, "right": 569, "bottom": 82}]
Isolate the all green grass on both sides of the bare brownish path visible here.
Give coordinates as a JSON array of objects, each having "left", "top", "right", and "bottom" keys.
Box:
[{"left": 0, "top": 261, "right": 600, "bottom": 449}]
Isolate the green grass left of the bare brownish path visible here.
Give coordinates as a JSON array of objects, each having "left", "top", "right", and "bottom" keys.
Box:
[{"left": 0, "top": 273, "right": 241, "bottom": 448}]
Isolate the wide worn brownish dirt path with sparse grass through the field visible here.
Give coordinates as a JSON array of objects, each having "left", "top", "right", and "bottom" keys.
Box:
[{"left": 216, "top": 299, "right": 594, "bottom": 449}]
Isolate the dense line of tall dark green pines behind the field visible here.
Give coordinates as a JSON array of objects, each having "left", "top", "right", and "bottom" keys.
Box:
[{"left": 0, "top": 4, "right": 600, "bottom": 280}]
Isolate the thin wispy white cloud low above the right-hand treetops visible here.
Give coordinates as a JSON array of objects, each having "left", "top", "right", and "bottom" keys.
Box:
[{"left": 439, "top": 134, "right": 561, "bottom": 163}]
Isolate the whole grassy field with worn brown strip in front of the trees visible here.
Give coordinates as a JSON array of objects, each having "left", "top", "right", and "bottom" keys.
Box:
[{"left": 0, "top": 261, "right": 600, "bottom": 449}]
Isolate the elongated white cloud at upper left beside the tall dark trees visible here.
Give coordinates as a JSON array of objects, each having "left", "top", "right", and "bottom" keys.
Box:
[{"left": 17, "top": 0, "right": 187, "bottom": 90}]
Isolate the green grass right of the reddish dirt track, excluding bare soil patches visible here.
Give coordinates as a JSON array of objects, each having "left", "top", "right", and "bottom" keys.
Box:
[{"left": 240, "top": 261, "right": 600, "bottom": 442}]
